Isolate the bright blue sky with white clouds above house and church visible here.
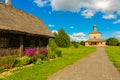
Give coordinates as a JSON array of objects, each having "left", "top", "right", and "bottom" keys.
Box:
[{"left": 3, "top": 0, "right": 120, "bottom": 41}]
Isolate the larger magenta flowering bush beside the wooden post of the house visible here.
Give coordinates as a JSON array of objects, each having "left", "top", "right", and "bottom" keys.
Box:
[{"left": 21, "top": 48, "right": 36, "bottom": 57}]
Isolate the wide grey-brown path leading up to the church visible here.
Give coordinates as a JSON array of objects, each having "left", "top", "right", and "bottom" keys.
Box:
[{"left": 48, "top": 47, "right": 120, "bottom": 80}]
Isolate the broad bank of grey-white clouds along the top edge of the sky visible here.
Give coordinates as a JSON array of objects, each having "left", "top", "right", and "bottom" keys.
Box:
[{"left": 34, "top": 0, "right": 120, "bottom": 19}]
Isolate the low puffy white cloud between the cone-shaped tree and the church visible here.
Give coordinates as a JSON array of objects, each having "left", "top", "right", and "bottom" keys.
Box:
[{"left": 70, "top": 32, "right": 87, "bottom": 42}]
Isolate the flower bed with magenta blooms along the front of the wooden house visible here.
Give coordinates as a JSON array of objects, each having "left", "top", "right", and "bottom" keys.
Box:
[{"left": 0, "top": 48, "right": 62, "bottom": 73}]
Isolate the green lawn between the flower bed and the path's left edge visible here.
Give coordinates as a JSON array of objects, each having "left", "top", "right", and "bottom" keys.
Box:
[{"left": 0, "top": 47, "right": 96, "bottom": 80}]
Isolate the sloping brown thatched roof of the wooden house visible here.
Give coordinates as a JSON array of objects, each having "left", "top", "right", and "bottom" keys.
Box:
[{"left": 0, "top": 3, "right": 54, "bottom": 37}]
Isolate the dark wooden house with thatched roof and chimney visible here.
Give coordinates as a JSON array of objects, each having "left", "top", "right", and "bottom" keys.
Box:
[{"left": 0, "top": 0, "right": 54, "bottom": 56}]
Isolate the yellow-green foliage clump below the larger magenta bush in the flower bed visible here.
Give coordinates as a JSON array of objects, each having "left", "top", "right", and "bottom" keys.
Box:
[{"left": 15, "top": 56, "right": 32, "bottom": 66}]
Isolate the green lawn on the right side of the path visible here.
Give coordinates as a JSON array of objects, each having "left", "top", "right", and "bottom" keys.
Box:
[{"left": 106, "top": 47, "right": 120, "bottom": 71}]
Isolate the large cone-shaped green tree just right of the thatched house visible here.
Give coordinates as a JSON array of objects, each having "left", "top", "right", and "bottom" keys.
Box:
[{"left": 55, "top": 29, "right": 70, "bottom": 47}]
